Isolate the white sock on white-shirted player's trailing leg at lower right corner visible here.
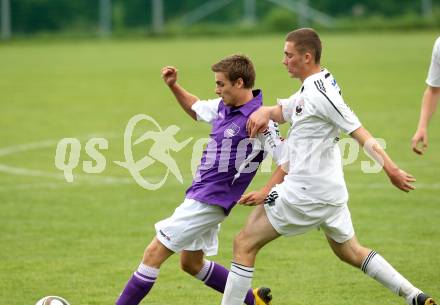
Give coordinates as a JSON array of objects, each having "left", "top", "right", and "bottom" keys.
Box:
[{"left": 361, "top": 251, "right": 421, "bottom": 304}]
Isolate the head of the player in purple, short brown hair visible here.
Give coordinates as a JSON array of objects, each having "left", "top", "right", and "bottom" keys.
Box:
[{"left": 211, "top": 55, "right": 255, "bottom": 106}]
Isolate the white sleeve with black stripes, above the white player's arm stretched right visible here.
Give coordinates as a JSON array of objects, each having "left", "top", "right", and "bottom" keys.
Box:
[{"left": 316, "top": 89, "right": 361, "bottom": 134}]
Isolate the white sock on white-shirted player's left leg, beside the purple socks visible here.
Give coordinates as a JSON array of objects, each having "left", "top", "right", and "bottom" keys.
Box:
[{"left": 222, "top": 263, "right": 254, "bottom": 305}]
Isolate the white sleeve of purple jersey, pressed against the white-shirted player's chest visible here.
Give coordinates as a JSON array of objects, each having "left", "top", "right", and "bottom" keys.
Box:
[{"left": 254, "top": 121, "right": 285, "bottom": 165}]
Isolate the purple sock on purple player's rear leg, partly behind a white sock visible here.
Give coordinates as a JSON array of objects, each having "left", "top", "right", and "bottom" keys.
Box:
[{"left": 199, "top": 261, "right": 255, "bottom": 305}]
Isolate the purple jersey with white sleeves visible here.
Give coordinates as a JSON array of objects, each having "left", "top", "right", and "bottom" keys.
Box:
[{"left": 186, "top": 90, "right": 281, "bottom": 214}]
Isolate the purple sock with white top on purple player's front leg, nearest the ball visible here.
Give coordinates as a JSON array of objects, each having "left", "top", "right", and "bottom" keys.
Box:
[{"left": 115, "top": 264, "right": 159, "bottom": 305}]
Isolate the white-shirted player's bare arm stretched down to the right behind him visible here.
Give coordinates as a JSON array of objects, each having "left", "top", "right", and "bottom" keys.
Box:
[{"left": 350, "top": 127, "right": 416, "bottom": 192}]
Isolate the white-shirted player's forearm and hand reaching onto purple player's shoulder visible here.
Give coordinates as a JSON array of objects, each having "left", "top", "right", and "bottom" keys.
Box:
[{"left": 246, "top": 105, "right": 284, "bottom": 138}]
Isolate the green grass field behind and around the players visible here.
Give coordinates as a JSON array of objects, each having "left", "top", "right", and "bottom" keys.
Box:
[{"left": 0, "top": 32, "right": 440, "bottom": 305}]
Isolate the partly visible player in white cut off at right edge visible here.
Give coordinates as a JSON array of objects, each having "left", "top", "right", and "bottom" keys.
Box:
[{"left": 411, "top": 37, "right": 440, "bottom": 155}]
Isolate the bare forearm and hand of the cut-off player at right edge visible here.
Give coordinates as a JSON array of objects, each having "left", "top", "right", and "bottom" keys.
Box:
[{"left": 411, "top": 86, "right": 440, "bottom": 155}]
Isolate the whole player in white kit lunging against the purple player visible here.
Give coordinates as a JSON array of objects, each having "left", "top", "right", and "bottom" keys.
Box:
[{"left": 222, "top": 29, "right": 435, "bottom": 305}]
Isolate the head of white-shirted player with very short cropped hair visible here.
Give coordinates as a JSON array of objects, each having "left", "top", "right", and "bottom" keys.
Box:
[{"left": 283, "top": 28, "right": 322, "bottom": 78}]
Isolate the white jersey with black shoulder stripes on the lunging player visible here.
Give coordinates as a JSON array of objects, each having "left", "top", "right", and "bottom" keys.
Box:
[{"left": 278, "top": 70, "right": 361, "bottom": 209}]
